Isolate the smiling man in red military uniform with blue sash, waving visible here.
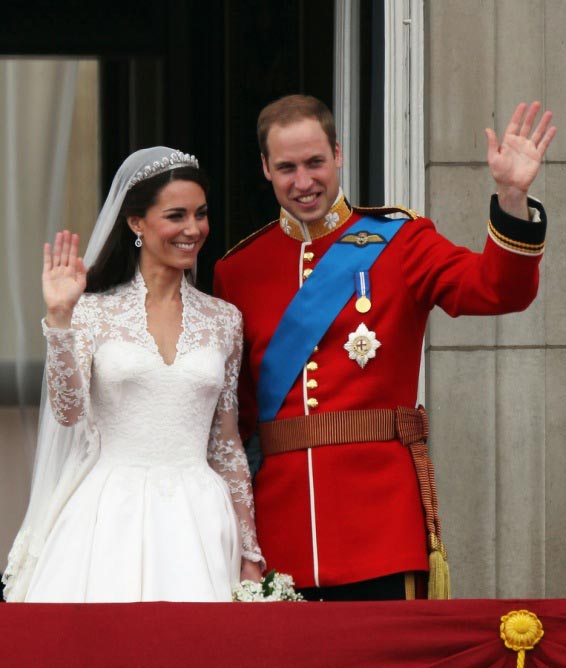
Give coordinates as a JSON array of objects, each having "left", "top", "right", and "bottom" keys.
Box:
[{"left": 215, "top": 95, "right": 555, "bottom": 600}]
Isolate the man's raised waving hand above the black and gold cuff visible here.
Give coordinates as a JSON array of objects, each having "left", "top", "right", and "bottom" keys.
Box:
[{"left": 485, "top": 102, "right": 556, "bottom": 218}]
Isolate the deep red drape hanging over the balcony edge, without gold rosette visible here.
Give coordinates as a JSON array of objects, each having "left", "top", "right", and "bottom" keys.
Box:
[{"left": 0, "top": 599, "right": 566, "bottom": 668}]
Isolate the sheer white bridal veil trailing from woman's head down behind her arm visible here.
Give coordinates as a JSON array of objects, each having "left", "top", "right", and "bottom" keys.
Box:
[{"left": 2, "top": 146, "right": 198, "bottom": 601}]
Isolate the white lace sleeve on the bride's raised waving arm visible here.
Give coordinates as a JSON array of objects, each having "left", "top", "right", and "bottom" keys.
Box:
[{"left": 41, "top": 298, "right": 92, "bottom": 426}]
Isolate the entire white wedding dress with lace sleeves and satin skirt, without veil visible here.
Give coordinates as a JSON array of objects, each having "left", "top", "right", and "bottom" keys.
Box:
[{"left": 21, "top": 272, "right": 262, "bottom": 602}]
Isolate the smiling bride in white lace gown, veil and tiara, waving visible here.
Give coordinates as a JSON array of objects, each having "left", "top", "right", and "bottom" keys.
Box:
[{"left": 4, "top": 147, "right": 264, "bottom": 602}]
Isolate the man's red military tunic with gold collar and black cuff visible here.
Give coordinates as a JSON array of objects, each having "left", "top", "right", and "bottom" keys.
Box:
[{"left": 215, "top": 190, "right": 546, "bottom": 587}]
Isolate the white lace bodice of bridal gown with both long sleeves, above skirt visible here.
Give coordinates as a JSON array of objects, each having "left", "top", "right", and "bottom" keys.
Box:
[{"left": 43, "top": 272, "right": 262, "bottom": 561}]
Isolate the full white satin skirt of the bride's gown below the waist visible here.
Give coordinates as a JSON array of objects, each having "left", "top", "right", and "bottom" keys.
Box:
[{"left": 26, "top": 460, "right": 241, "bottom": 603}]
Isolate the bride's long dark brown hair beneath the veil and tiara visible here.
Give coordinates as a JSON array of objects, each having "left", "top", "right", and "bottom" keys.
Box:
[{"left": 85, "top": 167, "right": 212, "bottom": 292}]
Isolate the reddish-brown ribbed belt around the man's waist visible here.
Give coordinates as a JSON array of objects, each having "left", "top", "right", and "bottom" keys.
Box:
[{"left": 259, "top": 407, "right": 428, "bottom": 456}]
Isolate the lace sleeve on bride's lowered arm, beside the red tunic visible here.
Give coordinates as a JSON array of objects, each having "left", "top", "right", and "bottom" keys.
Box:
[{"left": 208, "top": 312, "right": 265, "bottom": 568}]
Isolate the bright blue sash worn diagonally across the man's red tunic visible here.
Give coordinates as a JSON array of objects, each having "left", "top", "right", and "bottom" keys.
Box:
[{"left": 258, "top": 217, "right": 407, "bottom": 422}]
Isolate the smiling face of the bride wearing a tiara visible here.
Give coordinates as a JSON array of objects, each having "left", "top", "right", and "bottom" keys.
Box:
[{"left": 136, "top": 180, "right": 209, "bottom": 270}]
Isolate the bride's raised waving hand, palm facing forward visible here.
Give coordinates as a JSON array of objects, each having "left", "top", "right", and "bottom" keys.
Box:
[{"left": 41, "top": 230, "right": 86, "bottom": 328}]
